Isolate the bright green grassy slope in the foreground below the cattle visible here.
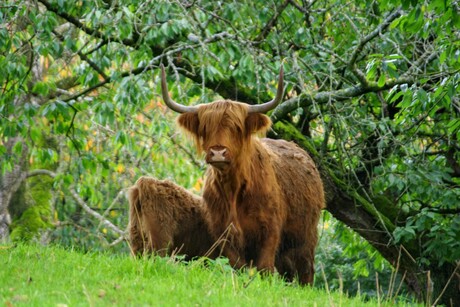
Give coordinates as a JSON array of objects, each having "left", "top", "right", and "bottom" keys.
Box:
[{"left": 0, "top": 245, "right": 414, "bottom": 307}]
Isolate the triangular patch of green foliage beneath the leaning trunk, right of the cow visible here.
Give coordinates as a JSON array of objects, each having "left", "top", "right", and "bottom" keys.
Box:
[{"left": 315, "top": 212, "right": 409, "bottom": 302}]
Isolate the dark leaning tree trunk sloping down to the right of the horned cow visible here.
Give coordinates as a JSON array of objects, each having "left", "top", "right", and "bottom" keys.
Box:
[{"left": 321, "top": 169, "right": 460, "bottom": 306}]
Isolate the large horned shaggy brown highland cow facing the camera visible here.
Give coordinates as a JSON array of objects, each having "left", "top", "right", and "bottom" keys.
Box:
[{"left": 161, "top": 66, "right": 324, "bottom": 284}]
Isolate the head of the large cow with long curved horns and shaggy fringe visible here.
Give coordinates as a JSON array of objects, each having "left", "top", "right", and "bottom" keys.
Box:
[{"left": 161, "top": 65, "right": 283, "bottom": 170}]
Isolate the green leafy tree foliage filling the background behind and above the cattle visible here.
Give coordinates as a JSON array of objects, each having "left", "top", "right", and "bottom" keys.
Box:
[{"left": 0, "top": 0, "right": 460, "bottom": 304}]
